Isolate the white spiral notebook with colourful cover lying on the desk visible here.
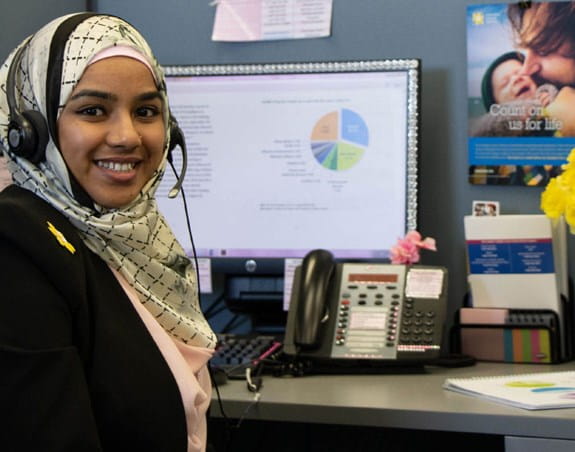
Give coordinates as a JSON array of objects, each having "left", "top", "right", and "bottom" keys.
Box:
[{"left": 443, "top": 371, "right": 575, "bottom": 410}]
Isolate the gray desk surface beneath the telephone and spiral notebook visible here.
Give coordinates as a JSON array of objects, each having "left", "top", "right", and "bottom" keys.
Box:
[{"left": 212, "top": 363, "right": 575, "bottom": 452}]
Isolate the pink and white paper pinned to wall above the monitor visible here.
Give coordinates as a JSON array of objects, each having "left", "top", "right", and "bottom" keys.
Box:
[{"left": 212, "top": 0, "right": 333, "bottom": 42}]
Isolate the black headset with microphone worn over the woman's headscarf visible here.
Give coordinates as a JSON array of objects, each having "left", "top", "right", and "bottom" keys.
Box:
[{"left": 6, "top": 13, "right": 188, "bottom": 198}]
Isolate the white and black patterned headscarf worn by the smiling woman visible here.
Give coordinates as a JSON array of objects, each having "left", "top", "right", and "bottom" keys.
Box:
[{"left": 0, "top": 14, "right": 215, "bottom": 347}]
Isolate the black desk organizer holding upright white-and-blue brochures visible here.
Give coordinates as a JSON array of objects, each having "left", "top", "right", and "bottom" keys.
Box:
[{"left": 459, "top": 215, "right": 572, "bottom": 362}]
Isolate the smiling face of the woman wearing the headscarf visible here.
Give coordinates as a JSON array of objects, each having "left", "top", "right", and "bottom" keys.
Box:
[{"left": 58, "top": 56, "right": 166, "bottom": 208}]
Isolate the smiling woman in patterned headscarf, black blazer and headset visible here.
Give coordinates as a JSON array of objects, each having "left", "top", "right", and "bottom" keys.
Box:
[{"left": 0, "top": 14, "right": 215, "bottom": 452}]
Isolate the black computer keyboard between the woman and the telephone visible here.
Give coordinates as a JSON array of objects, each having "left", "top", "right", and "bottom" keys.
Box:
[{"left": 210, "top": 334, "right": 282, "bottom": 376}]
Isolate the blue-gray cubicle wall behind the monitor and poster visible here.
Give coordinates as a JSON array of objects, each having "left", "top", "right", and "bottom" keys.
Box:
[{"left": 0, "top": 0, "right": 568, "bottom": 336}]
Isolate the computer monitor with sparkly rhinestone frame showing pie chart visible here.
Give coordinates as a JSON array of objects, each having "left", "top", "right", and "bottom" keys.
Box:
[{"left": 157, "top": 59, "right": 420, "bottom": 274}]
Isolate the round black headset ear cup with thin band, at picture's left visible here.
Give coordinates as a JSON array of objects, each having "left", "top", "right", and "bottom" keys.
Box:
[{"left": 6, "top": 43, "right": 49, "bottom": 164}]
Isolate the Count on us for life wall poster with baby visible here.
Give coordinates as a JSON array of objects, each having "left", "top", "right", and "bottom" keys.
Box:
[{"left": 467, "top": 1, "right": 575, "bottom": 186}]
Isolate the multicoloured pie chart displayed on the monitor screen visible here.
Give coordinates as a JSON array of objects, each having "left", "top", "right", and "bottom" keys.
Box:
[{"left": 311, "top": 108, "right": 369, "bottom": 171}]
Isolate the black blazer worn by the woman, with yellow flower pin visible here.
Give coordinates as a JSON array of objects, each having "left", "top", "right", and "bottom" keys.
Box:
[{"left": 0, "top": 186, "right": 187, "bottom": 452}]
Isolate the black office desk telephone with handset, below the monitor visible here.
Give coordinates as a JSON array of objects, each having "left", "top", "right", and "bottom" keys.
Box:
[{"left": 284, "top": 249, "right": 447, "bottom": 363}]
